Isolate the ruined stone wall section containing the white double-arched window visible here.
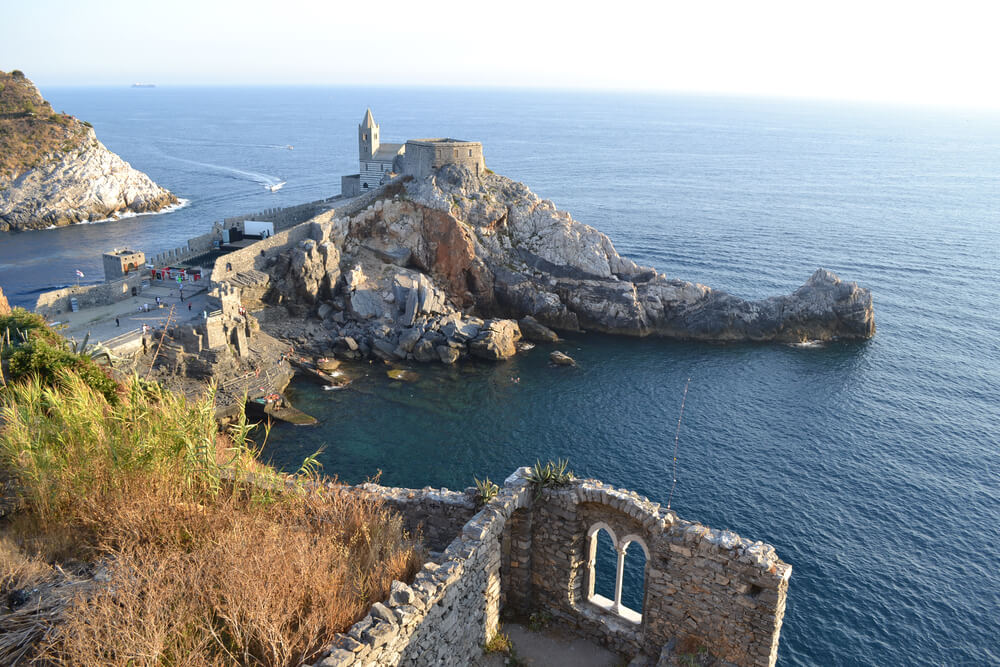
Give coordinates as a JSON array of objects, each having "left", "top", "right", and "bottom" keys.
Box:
[{"left": 531, "top": 480, "right": 791, "bottom": 666}]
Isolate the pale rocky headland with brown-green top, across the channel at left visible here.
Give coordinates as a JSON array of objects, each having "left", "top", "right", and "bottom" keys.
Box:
[{"left": 0, "top": 70, "right": 177, "bottom": 231}]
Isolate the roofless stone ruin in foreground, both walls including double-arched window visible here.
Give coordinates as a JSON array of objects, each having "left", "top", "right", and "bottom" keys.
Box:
[{"left": 306, "top": 468, "right": 791, "bottom": 667}]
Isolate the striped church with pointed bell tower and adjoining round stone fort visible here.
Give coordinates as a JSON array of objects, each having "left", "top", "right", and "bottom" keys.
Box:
[{"left": 340, "top": 109, "right": 486, "bottom": 197}]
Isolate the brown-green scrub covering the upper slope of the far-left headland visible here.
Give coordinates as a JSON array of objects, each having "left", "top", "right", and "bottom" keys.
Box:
[{"left": 0, "top": 70, "right": 90, "bottom": 187}]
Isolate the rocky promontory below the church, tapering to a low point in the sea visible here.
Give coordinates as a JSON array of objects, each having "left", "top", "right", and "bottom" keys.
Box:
[{"left": 263, "top": 165, "right": 875, "bottom": 363}]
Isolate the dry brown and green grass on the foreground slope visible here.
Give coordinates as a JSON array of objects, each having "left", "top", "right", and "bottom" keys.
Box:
[{"left": 0, "top": 376, "right": 421, "bottom": 665}]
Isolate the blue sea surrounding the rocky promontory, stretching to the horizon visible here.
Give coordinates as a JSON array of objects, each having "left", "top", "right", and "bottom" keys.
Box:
[{"left": 0, "top": 87, "right": 1000, "bottom": 666}]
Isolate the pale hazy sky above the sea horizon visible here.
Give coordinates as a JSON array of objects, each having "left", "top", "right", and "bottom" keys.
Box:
[{"left": 0, "top": 0, "right": 1000, "bottom": 109}]
